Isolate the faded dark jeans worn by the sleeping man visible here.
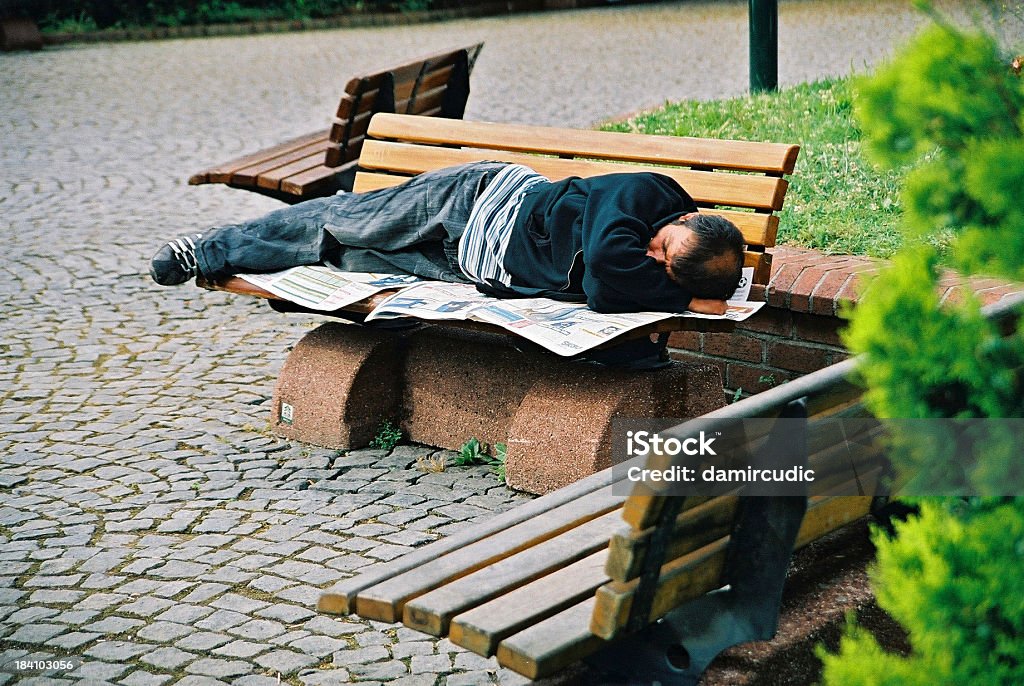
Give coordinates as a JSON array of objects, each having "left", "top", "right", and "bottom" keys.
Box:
[{"left": 196, "top": 162, "right": 505, "bottom": 282}]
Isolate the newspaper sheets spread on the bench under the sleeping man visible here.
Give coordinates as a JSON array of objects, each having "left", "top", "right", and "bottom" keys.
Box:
[{"left": 239, "top": 265, "right": 764, "bottom": 356}]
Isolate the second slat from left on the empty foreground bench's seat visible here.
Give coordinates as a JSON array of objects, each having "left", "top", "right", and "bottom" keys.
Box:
[{"left": 349, "top": 486, "right": 626, "bottom": 621}]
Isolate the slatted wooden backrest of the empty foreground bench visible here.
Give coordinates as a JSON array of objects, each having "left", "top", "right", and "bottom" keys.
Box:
[{"left": 591, "top": 360, "right": 882, "bottom": 639}]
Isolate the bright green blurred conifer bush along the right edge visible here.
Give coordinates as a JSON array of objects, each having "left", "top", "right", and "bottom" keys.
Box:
[{"left": 819, "top": 6, "right": 1024, "bottom": 686}]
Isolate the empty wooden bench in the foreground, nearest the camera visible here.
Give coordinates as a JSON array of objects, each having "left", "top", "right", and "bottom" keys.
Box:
[{"left": 319, "top": 360, "right": 880, "bottom": 684}]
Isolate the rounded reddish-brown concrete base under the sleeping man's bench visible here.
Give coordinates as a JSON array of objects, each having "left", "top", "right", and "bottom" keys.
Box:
[{"left": 271, "top": 323, "right": 724, "bottom": 494}]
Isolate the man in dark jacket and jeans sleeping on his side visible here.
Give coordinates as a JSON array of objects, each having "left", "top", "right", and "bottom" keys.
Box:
[{"left": 150, "top": 162, "right": 743, "bottom": 314}]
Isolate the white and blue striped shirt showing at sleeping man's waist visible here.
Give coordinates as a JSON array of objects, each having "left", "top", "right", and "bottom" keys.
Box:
[{"left": 459, "top": 165, "right": 549, "bottom": 286}]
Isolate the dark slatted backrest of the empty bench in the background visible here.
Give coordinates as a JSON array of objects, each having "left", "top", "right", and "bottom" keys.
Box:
[{"left": 326, "top": 43, "right": 483, "bottom": 167}]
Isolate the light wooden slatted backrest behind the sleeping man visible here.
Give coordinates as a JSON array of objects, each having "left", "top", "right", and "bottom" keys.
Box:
[{"left": 353, "top": 114, "right": 800, "bottom": 284}]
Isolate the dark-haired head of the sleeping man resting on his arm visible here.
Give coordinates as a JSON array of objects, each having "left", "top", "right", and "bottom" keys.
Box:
[{"left": 647, "top": 212, "right": 743, "bottom": 300}]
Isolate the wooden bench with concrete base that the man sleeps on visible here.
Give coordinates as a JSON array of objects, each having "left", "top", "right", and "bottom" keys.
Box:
[{"left": 200, "top": 113, "right": 800, "bottom": 492}]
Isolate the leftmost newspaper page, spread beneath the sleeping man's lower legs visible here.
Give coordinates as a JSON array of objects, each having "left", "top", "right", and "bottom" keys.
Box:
[{"left": 238, "top": 264, "right": 420, "bottom": 311}]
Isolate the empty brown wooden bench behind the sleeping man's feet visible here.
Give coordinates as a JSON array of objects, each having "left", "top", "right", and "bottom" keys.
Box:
[{"left": 188, "top": 43, "right": 483, "bottom": 203}]
